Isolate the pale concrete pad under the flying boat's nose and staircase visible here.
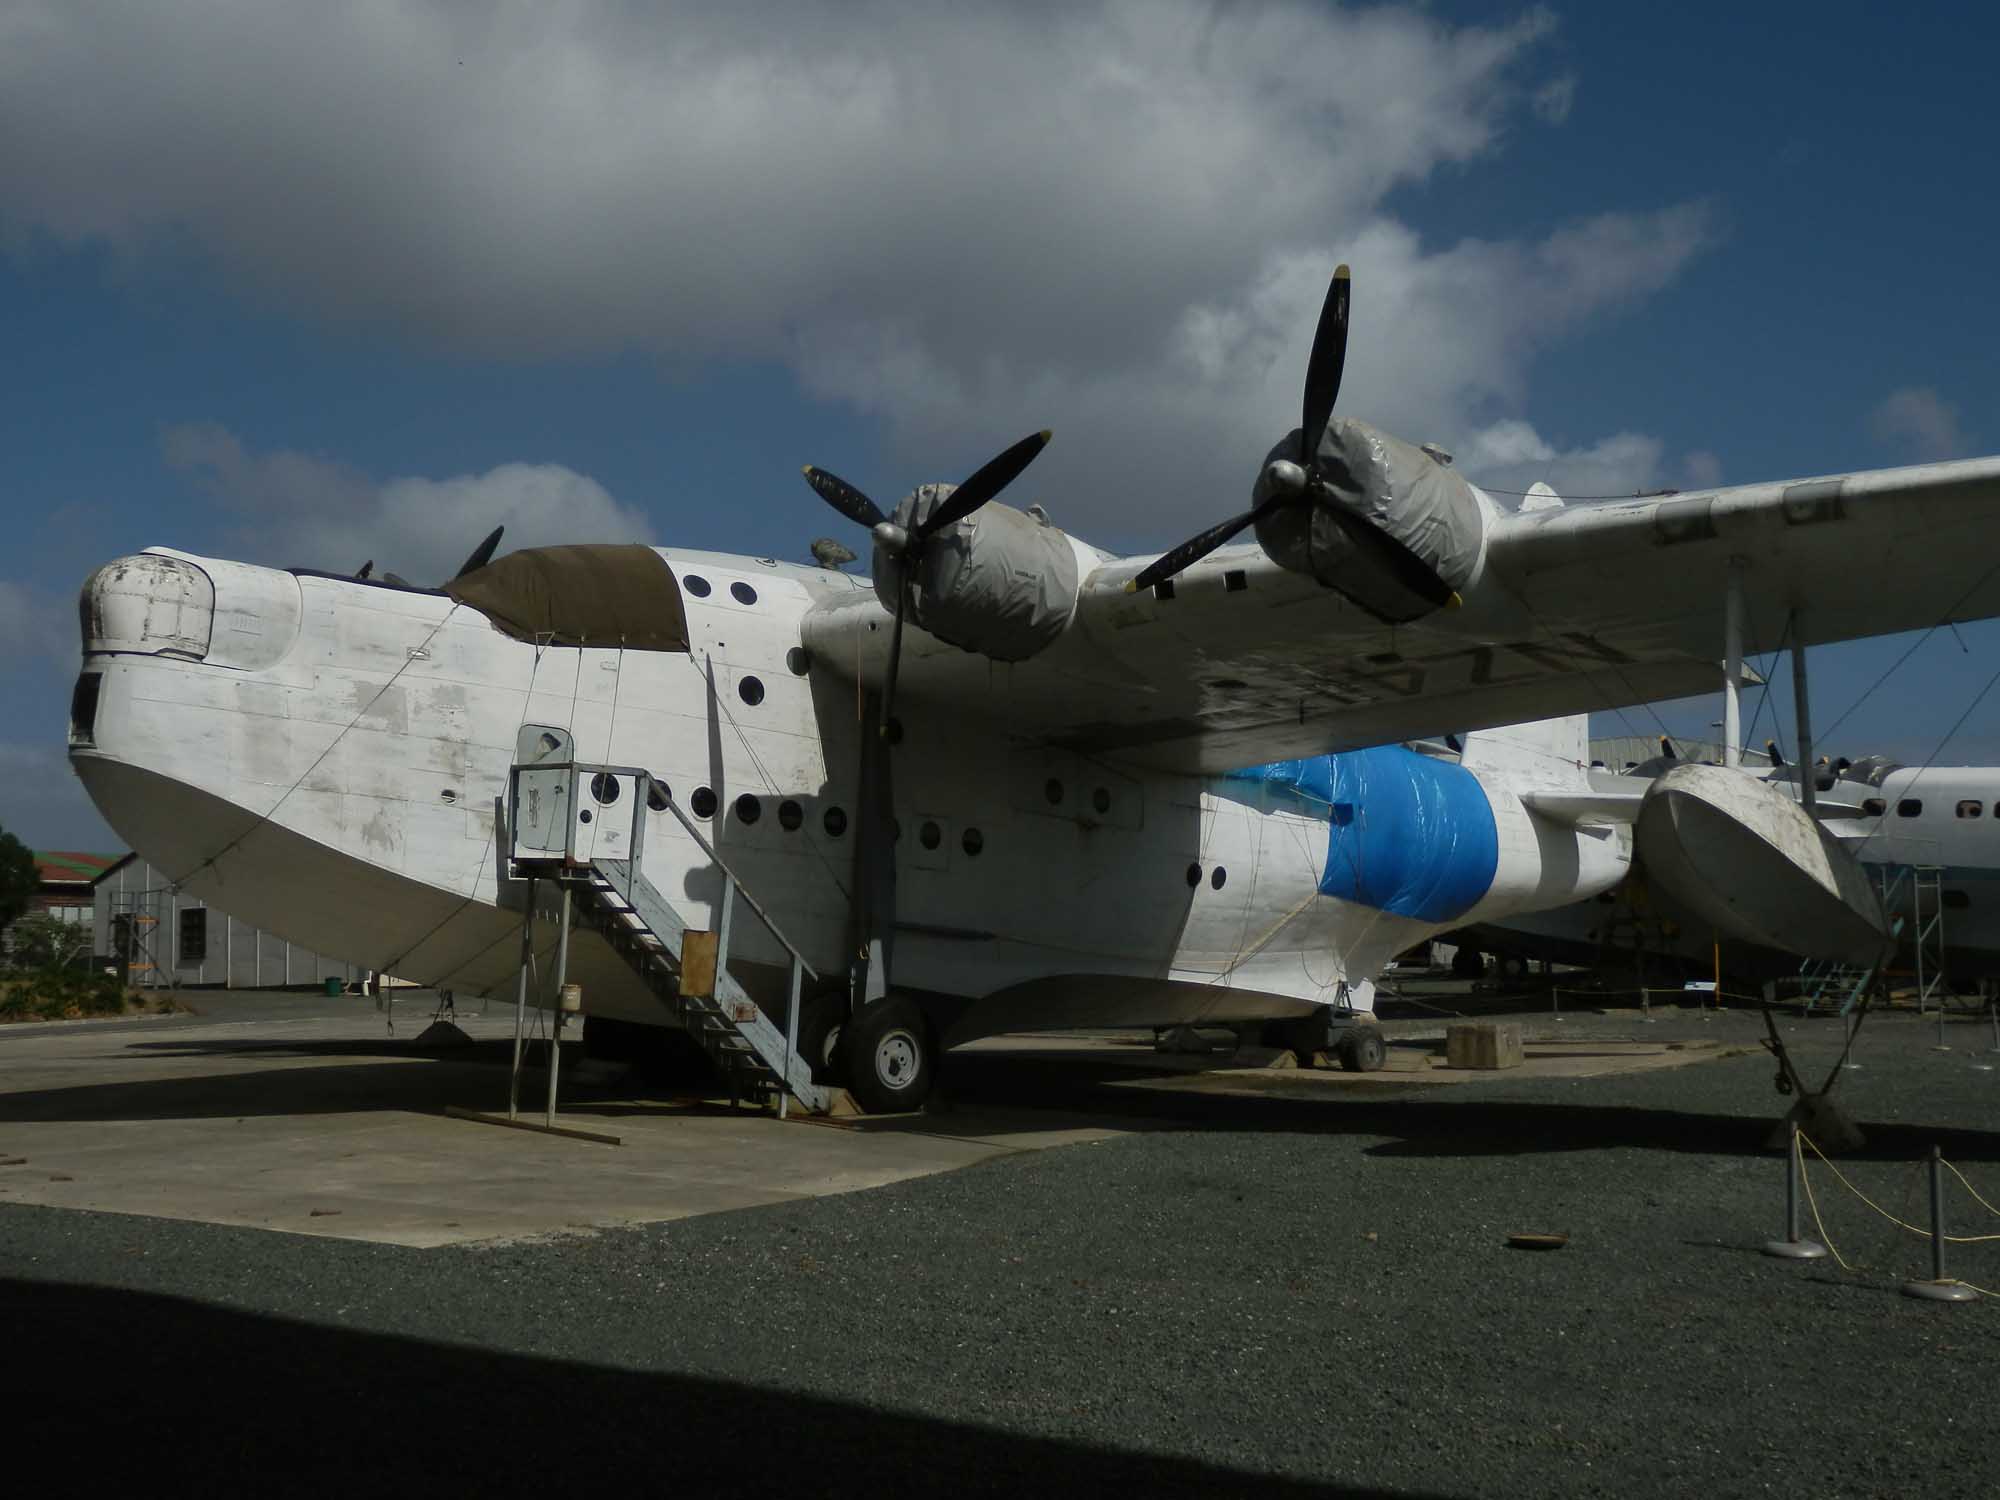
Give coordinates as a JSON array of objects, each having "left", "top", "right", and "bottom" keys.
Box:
[{"left": 0, "top": 1012, "right": 1116, "bottom": 1246}]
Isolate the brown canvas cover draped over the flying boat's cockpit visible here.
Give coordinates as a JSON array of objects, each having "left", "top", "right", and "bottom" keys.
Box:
[{"left": 444, "top": 546, "right": 688, "bottom": 652}]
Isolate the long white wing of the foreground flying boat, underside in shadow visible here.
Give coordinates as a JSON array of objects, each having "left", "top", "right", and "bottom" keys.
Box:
[{"left": 806, "top": 458, "right": 2000, "bottom": 772}]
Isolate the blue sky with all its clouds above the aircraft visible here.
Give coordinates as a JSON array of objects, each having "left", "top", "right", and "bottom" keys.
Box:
[{"left": 0, "top": 0, "right": 2000, "bottom": 848}]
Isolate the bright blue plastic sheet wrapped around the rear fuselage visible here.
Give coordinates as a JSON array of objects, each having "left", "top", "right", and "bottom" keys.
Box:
[{"left": 1226, "top": 746, "right": 1500, "bottom": 922}]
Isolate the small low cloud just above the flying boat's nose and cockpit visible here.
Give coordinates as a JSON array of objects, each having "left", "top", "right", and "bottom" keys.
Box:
[{"left": 160, "top": 422, "right": 650, "bottom": 584}]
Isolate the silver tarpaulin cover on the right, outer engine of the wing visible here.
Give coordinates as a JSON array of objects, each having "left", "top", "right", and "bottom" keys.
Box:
[{"left": 1252, "top": 418, "right": 1484, "bottom": 624}]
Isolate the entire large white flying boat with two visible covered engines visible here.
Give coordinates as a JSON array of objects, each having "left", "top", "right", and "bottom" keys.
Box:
[{"left": 70, "top": 268, "right": 2000, "bottom": 1110}]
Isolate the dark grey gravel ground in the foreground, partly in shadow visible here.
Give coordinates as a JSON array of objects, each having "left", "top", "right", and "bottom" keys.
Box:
[{"left": 0, "top": 1000, "right": 2000, "bottom": 1496}]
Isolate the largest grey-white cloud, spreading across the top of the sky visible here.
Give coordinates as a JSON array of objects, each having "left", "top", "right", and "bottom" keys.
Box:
[{"left": 0, "top": 0, "right": 1714, "bottom": 544}]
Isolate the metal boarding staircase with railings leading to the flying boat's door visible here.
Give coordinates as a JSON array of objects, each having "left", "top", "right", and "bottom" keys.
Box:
[{"left": 508, "top": 762, "right": 832, "bottom": 1114}]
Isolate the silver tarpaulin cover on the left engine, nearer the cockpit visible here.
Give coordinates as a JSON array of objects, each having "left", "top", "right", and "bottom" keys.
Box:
[{"left": 874, "top": 484, "right": 1076, "bottom": 662}]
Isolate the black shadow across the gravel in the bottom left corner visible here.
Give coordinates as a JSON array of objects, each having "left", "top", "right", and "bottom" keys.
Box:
[{"left": 0, "top": 1278, "right": 1432, "bottom": 1500}]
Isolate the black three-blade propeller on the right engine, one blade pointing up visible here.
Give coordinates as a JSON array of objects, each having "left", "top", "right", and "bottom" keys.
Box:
[{"left": 1126, "top": 266, "right": 1458, "bottom": 608}]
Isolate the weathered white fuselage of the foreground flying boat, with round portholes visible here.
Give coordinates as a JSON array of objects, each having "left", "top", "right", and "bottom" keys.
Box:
[{"left": 72, "top": 550, "right": 1628, "bottom": 1040}]
